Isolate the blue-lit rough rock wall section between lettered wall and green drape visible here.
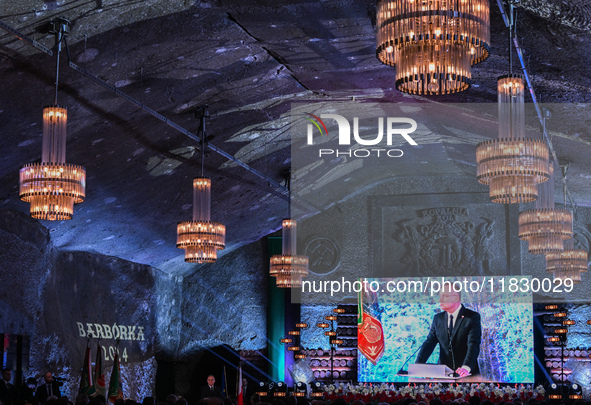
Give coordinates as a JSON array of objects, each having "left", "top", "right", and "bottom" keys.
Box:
[{"left": 179, "top": 240, "right": 268, "bottom": 357}]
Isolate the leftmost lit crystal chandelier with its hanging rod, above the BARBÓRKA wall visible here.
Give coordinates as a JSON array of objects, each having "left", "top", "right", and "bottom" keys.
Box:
[{"left": 19, "top": 19, "right": 86, "bottom": 221}]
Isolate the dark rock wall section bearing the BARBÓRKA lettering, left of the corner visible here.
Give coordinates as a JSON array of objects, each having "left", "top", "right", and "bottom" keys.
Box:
[{"left": 0, "top": 210, "right": 180, "bottom": 399}]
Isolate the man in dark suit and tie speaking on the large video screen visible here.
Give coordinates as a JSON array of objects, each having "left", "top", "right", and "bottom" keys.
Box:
[{"left": 416, "top": 284, "right": 482, "bottom": 377}]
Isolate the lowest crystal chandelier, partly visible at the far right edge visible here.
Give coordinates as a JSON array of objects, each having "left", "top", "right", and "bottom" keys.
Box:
[{"left": 546, "top": 238, "right": 589, "bottom": 283}]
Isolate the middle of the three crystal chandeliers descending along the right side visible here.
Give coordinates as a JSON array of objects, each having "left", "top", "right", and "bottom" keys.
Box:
[{"left": 519, "top": 165, "right": 573, "bottom": 255}]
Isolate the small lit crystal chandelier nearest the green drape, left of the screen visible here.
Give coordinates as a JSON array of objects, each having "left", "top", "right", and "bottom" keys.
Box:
[{"left": 269, "top": 218, "right": 308, "bottom": 288}]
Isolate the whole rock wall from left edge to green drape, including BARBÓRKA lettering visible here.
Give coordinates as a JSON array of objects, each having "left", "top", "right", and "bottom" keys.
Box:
[{"left": 0, "top": 210, "right": 268, "bottom": 399}]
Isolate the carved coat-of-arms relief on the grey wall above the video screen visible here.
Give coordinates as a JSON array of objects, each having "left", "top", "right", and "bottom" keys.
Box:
[{"left": 392, "top": 207, "right": 495, "bottom": 276}]
